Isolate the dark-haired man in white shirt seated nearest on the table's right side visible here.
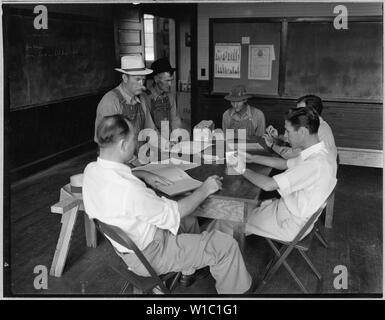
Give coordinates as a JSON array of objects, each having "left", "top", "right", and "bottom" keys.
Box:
[{"left": 210, "top": 107, "right": 337, "bottom": 241}]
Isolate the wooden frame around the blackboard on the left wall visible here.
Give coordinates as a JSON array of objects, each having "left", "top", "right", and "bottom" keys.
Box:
[{"left": 3, "top": 6, "right": 119, "bottom": 112}]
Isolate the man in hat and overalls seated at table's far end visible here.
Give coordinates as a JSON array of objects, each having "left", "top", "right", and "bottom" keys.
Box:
[{"left": 222, "top": 85, "right": 265, "bottom": 139}]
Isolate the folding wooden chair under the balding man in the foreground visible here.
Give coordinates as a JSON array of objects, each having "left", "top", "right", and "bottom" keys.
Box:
[{"left": 94, "top": 219, "right": 181, "bottom": 294}]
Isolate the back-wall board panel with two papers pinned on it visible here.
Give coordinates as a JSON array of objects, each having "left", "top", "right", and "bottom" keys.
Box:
[{"left": 210, "top": 19, "right": 281, "bottom": 95}]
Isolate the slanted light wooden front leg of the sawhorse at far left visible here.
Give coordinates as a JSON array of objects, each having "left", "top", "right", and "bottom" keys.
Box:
[{"left": 49, "top": 206, "right": 79, "bottom": 277}]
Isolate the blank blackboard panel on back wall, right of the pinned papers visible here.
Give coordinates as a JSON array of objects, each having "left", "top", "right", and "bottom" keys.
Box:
[{"left": 285, "top": 21, "right": 383, "bottom": 101}]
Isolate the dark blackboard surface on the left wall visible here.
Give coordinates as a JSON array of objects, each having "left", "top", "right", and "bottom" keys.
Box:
[{"left": 6, "top": 13, "right": 117, "bottom": 110}]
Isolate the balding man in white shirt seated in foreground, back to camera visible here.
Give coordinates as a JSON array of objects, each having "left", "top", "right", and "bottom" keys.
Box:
[{"left": 83, "top": 115, "right": 252, "bottom": 294}]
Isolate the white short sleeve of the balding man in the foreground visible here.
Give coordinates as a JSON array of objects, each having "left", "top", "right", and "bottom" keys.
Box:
[{"left": 127, "top": 187, "right": 180, "bottom": 235}]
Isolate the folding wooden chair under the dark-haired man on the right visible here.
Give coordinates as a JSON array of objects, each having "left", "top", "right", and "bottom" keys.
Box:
[{"left": 255, "top": 190, "right": 334, "bottom": 293}]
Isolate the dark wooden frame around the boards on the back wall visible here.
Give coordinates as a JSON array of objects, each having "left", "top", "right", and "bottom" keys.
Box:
[{"left": 208, "top": 16, "right": 383, "bottom": 104}]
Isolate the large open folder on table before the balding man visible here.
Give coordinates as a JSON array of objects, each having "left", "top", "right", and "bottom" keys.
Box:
[{"left": 136, "top": 166, "right": 202, "bottom": 196}]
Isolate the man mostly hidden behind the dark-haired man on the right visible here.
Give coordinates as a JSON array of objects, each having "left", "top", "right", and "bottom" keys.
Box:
[{"left": 264, "top": 94, "right": 337, "bottom": 159}]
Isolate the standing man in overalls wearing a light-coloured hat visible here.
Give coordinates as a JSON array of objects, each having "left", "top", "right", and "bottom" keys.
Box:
[{"left": 94, "top": 55, "right": 156, "bottom": 162}]
